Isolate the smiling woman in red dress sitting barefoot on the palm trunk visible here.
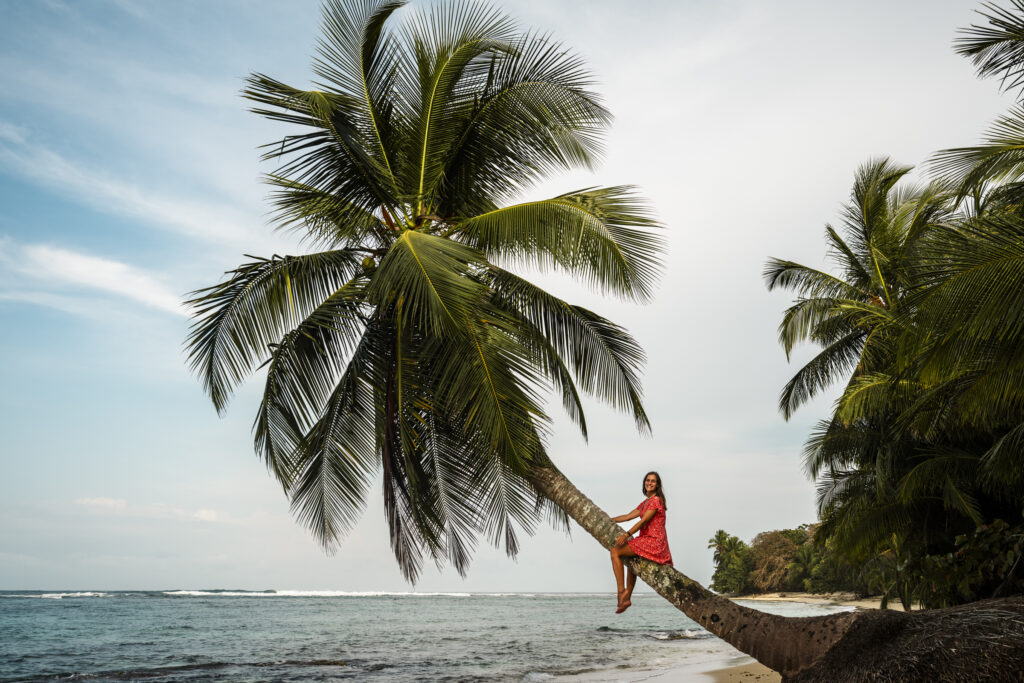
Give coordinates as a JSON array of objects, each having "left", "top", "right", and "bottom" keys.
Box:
[{"left": 611, "top": 472, "right": 672, "bottom": 614}]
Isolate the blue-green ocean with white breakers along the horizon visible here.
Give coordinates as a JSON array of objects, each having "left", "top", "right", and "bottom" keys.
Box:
[{"left": 0, "top": 590, "right": 844, "bottom": 683}]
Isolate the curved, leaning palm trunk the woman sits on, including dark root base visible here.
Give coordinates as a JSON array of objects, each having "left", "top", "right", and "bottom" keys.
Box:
[{"left": 531, "top": 465, "right": 1024, "bottom": 682}]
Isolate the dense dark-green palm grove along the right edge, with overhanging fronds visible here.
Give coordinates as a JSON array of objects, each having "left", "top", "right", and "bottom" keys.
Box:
[{"left": 765, "top": 0, "right": 1024, "bottom": 605}]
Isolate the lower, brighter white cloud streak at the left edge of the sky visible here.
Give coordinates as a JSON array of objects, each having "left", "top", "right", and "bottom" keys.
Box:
[{"left": 0, "top": 241, "right": 188, "bottom": 315}]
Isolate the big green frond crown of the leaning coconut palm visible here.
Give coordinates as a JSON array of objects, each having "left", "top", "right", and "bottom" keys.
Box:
[{"left": 186, "top": 0, "right": 663, "bottom": 581}]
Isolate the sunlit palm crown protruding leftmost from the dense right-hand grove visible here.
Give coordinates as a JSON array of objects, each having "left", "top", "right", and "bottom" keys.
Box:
[{"left": 764, "top": 159, "right": 950, "bottom": 419}]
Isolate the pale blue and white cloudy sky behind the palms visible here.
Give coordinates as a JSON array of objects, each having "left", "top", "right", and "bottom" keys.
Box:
[{"left": 0, "top": 0, "right": 1012, "bottom": 592}]
